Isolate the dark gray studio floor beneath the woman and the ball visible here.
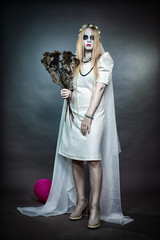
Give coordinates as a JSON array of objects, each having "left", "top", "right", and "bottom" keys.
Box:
[{"left": 1, "top": 189, "right": 160, "bottom": 240}]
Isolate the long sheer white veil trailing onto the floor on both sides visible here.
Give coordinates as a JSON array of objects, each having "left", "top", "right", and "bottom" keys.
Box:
[{"left": 17, "top": 47, "right": 133, "bottom": 225}]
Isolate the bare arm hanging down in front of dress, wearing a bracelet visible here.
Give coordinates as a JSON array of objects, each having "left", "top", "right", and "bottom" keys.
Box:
[{"left": 81, "top": 82, "right": 107, "bottom": 136}]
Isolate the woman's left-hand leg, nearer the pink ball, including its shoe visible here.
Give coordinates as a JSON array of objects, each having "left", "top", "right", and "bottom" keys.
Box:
[{"left": 69, "top": 160, "right": 88, "bottom": 220}]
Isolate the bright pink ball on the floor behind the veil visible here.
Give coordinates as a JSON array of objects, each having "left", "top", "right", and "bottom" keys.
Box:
[{"left": 34, "top": 179, "right": 52, "bottom": 202}]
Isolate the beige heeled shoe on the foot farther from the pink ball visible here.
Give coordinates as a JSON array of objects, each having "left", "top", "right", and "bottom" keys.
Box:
[{"left": 88, "top": 208, "right": 101, "bottom": 229}]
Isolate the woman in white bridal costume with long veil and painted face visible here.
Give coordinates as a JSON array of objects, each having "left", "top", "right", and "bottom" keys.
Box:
[{"left": 18, "top": 24, "right": 133, "bottom": 229}]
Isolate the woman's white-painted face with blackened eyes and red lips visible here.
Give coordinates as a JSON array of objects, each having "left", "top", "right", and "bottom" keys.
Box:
[{"left": 83, "top": 28, "right": 94, "bottom": 50}]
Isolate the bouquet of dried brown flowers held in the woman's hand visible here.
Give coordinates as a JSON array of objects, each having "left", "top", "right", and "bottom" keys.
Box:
[{"left": 41, "top": 51, "right": 79, "bottom": 125}]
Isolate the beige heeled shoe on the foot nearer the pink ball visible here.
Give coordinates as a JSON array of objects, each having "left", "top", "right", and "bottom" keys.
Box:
[{"left": 69, "top": 199, "right": 89, "bottom": 220}]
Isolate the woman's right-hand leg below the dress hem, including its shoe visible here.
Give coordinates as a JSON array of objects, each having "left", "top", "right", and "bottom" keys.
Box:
[{"left": 88, "top": 161, "right": 102, "bottom": 228}]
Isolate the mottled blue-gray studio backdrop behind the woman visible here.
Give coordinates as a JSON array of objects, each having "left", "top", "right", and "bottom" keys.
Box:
[{"left": 1, "top": 1, "right": 160, "bottom": 198}]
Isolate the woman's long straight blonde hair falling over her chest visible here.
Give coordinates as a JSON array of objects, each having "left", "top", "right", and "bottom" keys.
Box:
[{"left": 75, "top": 24, "right": 101, "bottom": 78}]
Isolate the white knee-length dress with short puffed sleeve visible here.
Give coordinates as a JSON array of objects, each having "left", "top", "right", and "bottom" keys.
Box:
[{"left": 59, "top": 52, "right": 113, "bottom": 161}]
